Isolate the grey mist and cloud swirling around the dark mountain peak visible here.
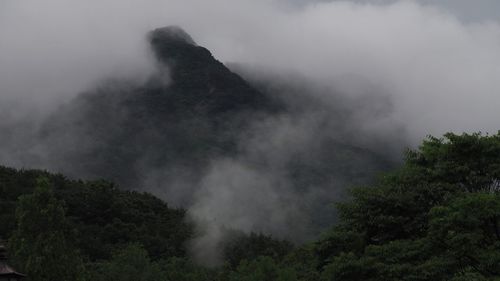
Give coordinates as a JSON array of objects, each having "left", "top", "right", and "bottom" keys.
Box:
[{"left": 0, "top": 0, "right": 500, "bottom": 260}]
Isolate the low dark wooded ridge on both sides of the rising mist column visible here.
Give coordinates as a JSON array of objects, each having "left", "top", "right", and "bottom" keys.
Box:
[{"left": 0, "top": 163, "right": 292, "bottom": 264}]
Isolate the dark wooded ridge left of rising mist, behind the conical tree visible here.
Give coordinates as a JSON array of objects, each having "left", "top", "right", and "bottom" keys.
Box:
[{"left": 0, "top": 164, "right": 192, "bottom": 260}]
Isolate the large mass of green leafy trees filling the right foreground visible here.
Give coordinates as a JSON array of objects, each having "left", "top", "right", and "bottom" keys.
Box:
[{"left": 316, "top": 133, "right": 500, "bottom": 281}]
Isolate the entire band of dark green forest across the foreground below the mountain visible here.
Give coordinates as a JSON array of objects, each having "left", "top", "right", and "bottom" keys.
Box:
[{"left": 0, "top": 134, "right": 500, "bottom": 281}]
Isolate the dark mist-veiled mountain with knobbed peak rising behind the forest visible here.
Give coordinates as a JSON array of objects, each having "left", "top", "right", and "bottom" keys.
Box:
[{"left": 10, "top": 26, "right": 394, "bottom": 237}]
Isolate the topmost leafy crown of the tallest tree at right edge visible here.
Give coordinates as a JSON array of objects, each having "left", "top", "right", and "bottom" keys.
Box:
[{"left": 404, "top": 132, "right": 500, "bottom": 192}]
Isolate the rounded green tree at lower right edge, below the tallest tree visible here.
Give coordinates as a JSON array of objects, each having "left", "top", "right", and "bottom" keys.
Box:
[{"left": 429, "top": 193, "right": 500, "bottom": 277}]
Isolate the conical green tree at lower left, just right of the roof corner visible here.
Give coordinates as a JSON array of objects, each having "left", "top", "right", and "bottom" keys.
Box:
[{"left": 9, "top": 178, "right": 85, "bottom": 281}]
